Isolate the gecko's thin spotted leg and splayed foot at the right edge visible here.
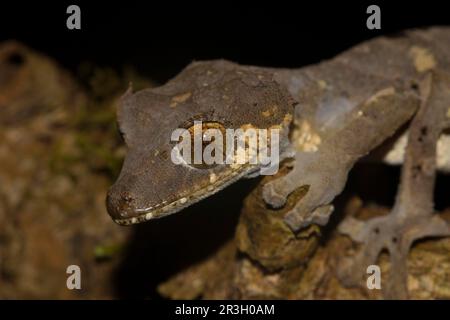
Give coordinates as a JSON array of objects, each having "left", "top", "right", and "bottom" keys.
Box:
[{"left": 338, "top": 73, "right": 450, "bottom": 299}]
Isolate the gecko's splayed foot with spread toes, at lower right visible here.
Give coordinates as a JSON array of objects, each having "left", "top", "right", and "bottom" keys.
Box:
[{"left": 338, "top": 213, "right": 450, "bottom": 299}]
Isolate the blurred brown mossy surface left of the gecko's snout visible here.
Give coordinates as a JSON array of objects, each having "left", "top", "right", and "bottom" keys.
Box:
[{"left": 0, "top": 42, "right": 152, "bottom": 299}]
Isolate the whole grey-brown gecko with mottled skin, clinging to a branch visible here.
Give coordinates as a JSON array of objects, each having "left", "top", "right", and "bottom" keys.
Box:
[{"left": 107, "top": 27, "right": 450, "bottom": 299}]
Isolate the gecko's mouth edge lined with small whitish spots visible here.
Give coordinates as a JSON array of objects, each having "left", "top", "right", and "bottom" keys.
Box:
[{"left": 110, "top": 164, "right": 255, "bottom": 225}]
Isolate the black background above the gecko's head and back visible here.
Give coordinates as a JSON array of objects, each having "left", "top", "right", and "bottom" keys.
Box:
[{"left": 0, "top": 0, "right": 450, "bottom": 81}]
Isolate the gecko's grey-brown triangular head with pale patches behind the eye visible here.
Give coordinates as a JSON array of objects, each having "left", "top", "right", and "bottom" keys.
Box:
[{"left": 107, "top": 60, "right": 294, "bottom": 225}]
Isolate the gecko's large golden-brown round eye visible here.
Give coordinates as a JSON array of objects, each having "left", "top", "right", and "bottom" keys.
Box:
[{"left": 188, "top": 122, "right": 226, "bottom": 169}]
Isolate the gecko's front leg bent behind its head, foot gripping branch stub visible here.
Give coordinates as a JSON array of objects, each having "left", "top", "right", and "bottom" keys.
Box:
[{"left": 263, "top": 81, "right": 418, "bottom": 232}]
